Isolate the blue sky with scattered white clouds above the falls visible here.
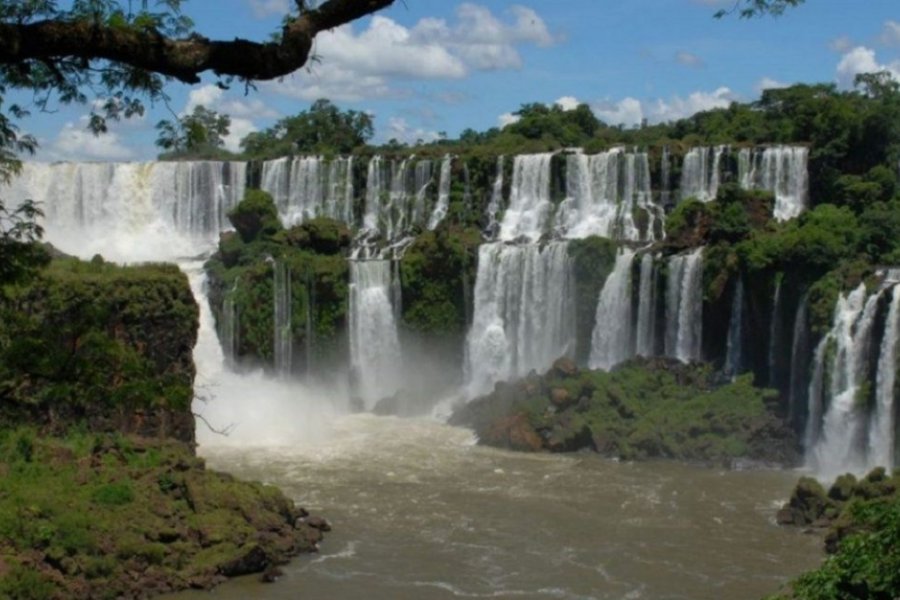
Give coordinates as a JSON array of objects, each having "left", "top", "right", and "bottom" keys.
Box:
[{"left": 8, "top": 0, "right": 900, "bottom": 161}]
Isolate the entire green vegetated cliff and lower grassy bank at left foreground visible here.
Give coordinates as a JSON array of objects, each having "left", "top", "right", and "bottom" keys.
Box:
[{"left": 0, "top": 257, "right": 327, "bottom": 599}]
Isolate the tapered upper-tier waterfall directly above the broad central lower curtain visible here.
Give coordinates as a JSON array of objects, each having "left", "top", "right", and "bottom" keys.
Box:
[{"left": 500, "top": 152, "right": 553, "bottom": 242}]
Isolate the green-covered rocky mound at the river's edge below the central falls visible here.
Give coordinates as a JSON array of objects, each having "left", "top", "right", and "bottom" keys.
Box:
[{"left": 451, "top": 358, "right": 799, "bottom": 465}]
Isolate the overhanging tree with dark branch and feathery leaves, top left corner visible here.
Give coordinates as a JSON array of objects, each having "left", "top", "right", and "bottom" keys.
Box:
[{"left": 0, "top": 0, "right": 394, "bottom": 162}]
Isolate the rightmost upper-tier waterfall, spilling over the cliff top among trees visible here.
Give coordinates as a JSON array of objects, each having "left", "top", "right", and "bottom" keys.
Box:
[{"left": 738, "top": 146, "right": 809, "bottom": 221}]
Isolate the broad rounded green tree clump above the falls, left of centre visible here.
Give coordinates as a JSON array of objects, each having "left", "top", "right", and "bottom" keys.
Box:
[{"left": 241, "top": 99, "right": 374, "bottom": 159}]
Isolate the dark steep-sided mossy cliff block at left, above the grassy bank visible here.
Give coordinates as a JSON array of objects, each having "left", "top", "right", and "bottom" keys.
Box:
[{"left": 0, "top": 260, "right": 197, "bottom": 421}]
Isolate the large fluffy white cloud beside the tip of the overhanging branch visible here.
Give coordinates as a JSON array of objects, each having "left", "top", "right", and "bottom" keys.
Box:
[{"left": 267, "top": 3, "right": 556, "bottom": 101}]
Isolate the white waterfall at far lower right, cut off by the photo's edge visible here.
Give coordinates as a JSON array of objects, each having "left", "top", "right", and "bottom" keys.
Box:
[{"left": 869, "top": 285, "right": 900, "bottom": 472}]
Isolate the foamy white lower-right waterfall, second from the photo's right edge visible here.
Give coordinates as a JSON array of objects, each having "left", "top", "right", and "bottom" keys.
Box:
[{"left": 806, "top": 284, "right": 881, "bottom": 476}]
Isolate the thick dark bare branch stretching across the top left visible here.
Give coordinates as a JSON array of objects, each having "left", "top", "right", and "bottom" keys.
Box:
[{"left": 0, "top": 0, "right": 394, "bottom": 83}]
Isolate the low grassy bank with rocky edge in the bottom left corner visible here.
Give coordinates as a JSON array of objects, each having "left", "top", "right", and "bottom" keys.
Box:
[{"left": 0, "top": 427, "right": 317, "bottom": 598}]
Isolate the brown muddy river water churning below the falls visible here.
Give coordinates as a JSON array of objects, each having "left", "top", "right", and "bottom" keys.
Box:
[{"left": 170, "top": 415, "right": 822, "bottom": 600}]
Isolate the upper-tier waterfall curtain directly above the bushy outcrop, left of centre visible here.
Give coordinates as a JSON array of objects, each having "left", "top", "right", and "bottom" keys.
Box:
[{"left": 260, "top": 156, "right": 353, "bottom": 226}]
